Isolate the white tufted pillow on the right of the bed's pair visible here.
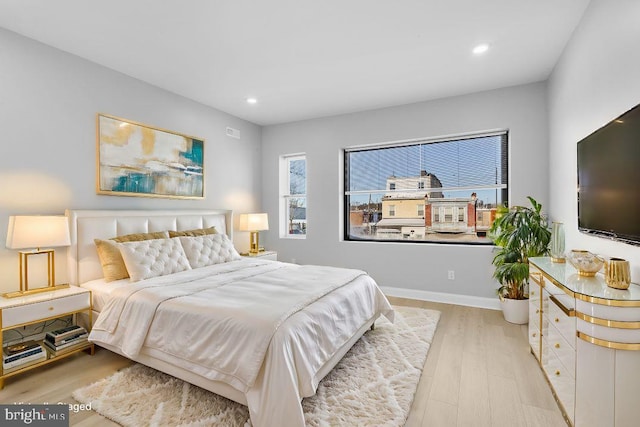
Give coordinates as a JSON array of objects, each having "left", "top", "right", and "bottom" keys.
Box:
[{"left": 178, "top": 234, "right": 242, "bottom": 268}]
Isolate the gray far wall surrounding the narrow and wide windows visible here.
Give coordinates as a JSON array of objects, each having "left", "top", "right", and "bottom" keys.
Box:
[{"left": 262, "top": 83, "right": 549, "bottom": 305}]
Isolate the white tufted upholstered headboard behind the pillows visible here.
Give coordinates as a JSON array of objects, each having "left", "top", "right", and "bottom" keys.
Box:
[{"left": 65, "top": 209, "right": 233, "bottom": 285}]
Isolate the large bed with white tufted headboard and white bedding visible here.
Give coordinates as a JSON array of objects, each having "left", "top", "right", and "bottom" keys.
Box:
[{"left": 66, "top": 210, "right": 393, "bottom": 427}]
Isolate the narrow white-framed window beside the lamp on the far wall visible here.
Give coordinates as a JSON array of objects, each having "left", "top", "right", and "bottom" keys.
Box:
[{"left": 280, "top": 154, "right": 307, "bottom": 238}]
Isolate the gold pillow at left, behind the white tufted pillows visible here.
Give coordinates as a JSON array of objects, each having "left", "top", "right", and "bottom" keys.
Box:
[{"left": 94, "top": 231, "right": 169, "bottom": 282}]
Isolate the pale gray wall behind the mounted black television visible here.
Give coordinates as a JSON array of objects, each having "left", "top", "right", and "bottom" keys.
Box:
[{"left": 548, "top": 0, "right": 640, "bottom": 283}]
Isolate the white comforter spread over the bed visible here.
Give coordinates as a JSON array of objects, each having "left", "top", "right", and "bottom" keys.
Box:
[{"left": 90, "top": 260, "right": 393, "bottom": 426}]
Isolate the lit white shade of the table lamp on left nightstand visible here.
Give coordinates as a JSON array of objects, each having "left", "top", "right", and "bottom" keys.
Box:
[{"left": 7, "top": 215, "right": 71, "bottom": 249}]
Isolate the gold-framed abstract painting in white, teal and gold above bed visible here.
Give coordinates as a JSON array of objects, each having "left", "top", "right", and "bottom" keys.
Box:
[{"left": 96, "top": 114, "right": 204, "bottom": 199}]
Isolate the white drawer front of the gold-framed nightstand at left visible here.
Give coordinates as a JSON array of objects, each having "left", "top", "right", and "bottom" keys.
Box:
[{"left": 2, "top": 292, "right": 91, "bottom": 329}]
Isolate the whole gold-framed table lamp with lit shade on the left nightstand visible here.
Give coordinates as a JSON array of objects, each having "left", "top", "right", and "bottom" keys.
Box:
[{"left": 3, "top": 215, "right": 70, "bottom": 298}]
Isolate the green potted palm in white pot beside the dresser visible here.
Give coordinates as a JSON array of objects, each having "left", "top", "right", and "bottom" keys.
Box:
[{"left": 489, "top": 197, "right": 551, "bottom": 324}]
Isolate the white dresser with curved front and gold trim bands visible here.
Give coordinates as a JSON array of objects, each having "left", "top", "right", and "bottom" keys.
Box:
[{"left": 529, "top": 257, "right": 640, "bottom": 427}]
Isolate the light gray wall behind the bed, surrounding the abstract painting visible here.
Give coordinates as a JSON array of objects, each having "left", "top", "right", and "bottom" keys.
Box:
[{"left": 0, "top": 29, "right": 261, "bottom": 292}]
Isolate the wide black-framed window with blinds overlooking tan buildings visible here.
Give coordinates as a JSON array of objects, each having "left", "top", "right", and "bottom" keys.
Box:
[{"left": 343, "top": 131, "right": 508, "bottom": 244}]
